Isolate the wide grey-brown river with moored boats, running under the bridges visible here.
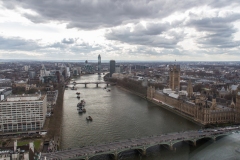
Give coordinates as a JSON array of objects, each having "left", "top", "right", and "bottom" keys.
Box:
[{"left": 61, "top": 74, "right": 240, "bottom": 160}]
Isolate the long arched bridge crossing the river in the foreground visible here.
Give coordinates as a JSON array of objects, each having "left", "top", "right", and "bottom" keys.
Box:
[{"left": 41, "top": 127, "right": 240, "bottom": 160}]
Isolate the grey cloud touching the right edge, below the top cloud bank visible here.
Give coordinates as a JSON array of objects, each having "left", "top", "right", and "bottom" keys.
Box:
[{"left": 186, "top": 14, "right": 240, "bottom": 48}]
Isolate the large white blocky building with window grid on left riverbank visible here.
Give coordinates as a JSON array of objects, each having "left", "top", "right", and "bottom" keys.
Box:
[{"left": 0, "top": 94, "right": 47, "bottom": 132}]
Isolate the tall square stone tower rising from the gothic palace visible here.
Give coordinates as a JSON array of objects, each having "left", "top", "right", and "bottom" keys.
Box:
[{"left": 169, "top": 65, "right": 180, "bottom": 91}]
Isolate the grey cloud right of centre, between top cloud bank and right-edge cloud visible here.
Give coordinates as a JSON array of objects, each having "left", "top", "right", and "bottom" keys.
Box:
[{"left": 105, "top": 23, "right": 184, "bottom": 48}]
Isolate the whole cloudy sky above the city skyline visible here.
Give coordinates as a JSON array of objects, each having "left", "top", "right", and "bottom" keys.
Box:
[{"left": 0, "top": 0, "right": 240, "bottom": 61}]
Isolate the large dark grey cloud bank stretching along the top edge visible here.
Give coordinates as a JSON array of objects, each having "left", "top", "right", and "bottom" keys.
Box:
[{"left": 2, "top": 0, "right": 238, "bottom": 30}]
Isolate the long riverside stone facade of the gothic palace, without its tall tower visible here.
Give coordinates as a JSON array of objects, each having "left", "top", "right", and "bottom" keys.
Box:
[{"left": 147, "top": 86, "right": 240, "bottom": 125}]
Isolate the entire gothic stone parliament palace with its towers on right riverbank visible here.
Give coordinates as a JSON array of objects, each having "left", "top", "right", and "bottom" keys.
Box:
[{"left": 147, "top": 65, "right": 240, "bottom": 125}]
